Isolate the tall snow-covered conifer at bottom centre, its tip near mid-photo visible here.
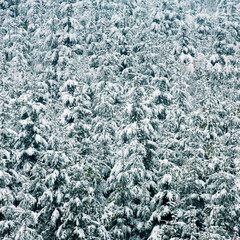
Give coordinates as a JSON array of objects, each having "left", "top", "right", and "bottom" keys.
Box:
[{"left": 102, "top": 72, "right": 161, "bottom": 239}]
